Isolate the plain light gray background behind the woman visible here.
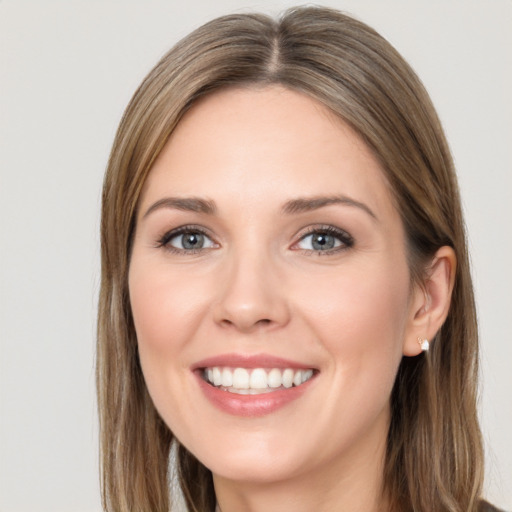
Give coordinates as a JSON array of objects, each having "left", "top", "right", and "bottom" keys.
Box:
[{"left": 0, "top": 0, "right": 512, "bottom": 512}]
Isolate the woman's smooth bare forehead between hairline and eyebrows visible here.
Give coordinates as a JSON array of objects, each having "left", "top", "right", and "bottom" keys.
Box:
[{"left": 142, "top": 86, "right": 391, "bottom": 216}]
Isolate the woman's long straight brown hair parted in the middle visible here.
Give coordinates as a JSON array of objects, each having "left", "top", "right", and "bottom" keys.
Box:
[{"left": 97, "top": 7, "right": 483, "bottom": 512}]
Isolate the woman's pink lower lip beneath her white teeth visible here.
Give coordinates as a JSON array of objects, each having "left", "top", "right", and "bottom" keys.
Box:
[{"left": 196, "top": 373, "right": 314, "bottom": 417}]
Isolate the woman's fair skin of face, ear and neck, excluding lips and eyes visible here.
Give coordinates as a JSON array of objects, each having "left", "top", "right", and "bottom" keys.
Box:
[{"left": 129, "top": 86, "right": 455, "bottom": 512}]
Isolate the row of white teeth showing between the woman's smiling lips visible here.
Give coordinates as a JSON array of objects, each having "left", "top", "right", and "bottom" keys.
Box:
[{"left": 201, "top": 366, "right": 315, "bottom": 395}]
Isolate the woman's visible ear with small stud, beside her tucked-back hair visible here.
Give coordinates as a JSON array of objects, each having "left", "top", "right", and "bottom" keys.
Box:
[{"left": 403, "top": 246, "right": 457, "bottom": 356}]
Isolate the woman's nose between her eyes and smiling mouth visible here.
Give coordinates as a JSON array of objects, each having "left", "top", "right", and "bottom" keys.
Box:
[{"left": 213, "top": 254, "right": 290, "bottom": 333}]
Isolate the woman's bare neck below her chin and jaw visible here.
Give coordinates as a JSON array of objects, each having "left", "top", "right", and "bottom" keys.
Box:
[{"left": 213, "top": 416, "right": 389, "bottom": 512}]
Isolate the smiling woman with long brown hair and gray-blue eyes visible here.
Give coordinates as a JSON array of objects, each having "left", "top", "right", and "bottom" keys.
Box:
[{"left": 97, "top": 8, "right": 500, "bottom": 512}]
